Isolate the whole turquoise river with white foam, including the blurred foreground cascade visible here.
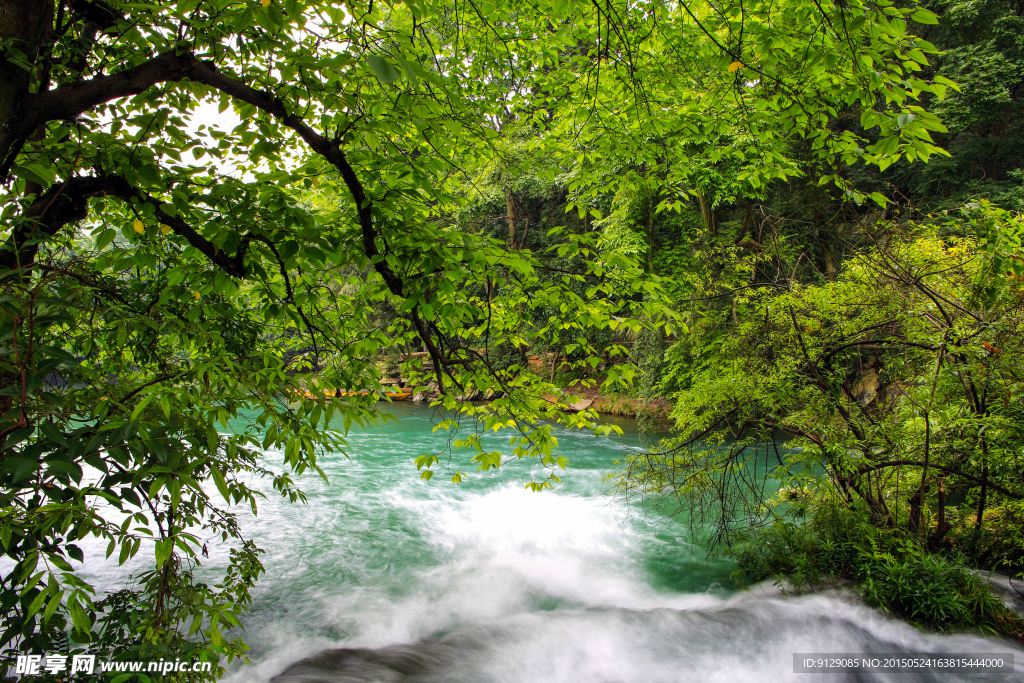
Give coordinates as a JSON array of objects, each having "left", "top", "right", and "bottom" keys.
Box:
[{"left": 81, "top": 403, "right": 1024, "bottom": 683}]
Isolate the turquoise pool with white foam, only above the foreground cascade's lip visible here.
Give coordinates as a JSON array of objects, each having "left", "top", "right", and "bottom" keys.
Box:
[{"left": 220, "top": 403, "right": 732, "bottom": 681}]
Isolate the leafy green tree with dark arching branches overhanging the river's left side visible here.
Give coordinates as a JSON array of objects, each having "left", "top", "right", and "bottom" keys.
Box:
[{"left": 0, "top": 0, "right": 671, "bottom": 665}]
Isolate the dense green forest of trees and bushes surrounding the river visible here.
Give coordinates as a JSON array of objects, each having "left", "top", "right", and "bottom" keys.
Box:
[{"left": 0, "top": 0, "right": 1024, "bottom": 681}]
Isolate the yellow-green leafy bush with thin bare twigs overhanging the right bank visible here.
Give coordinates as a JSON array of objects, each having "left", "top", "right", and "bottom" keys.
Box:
[{"left": 620, "top": 205, "right": 1024, "bottom": 566}]
